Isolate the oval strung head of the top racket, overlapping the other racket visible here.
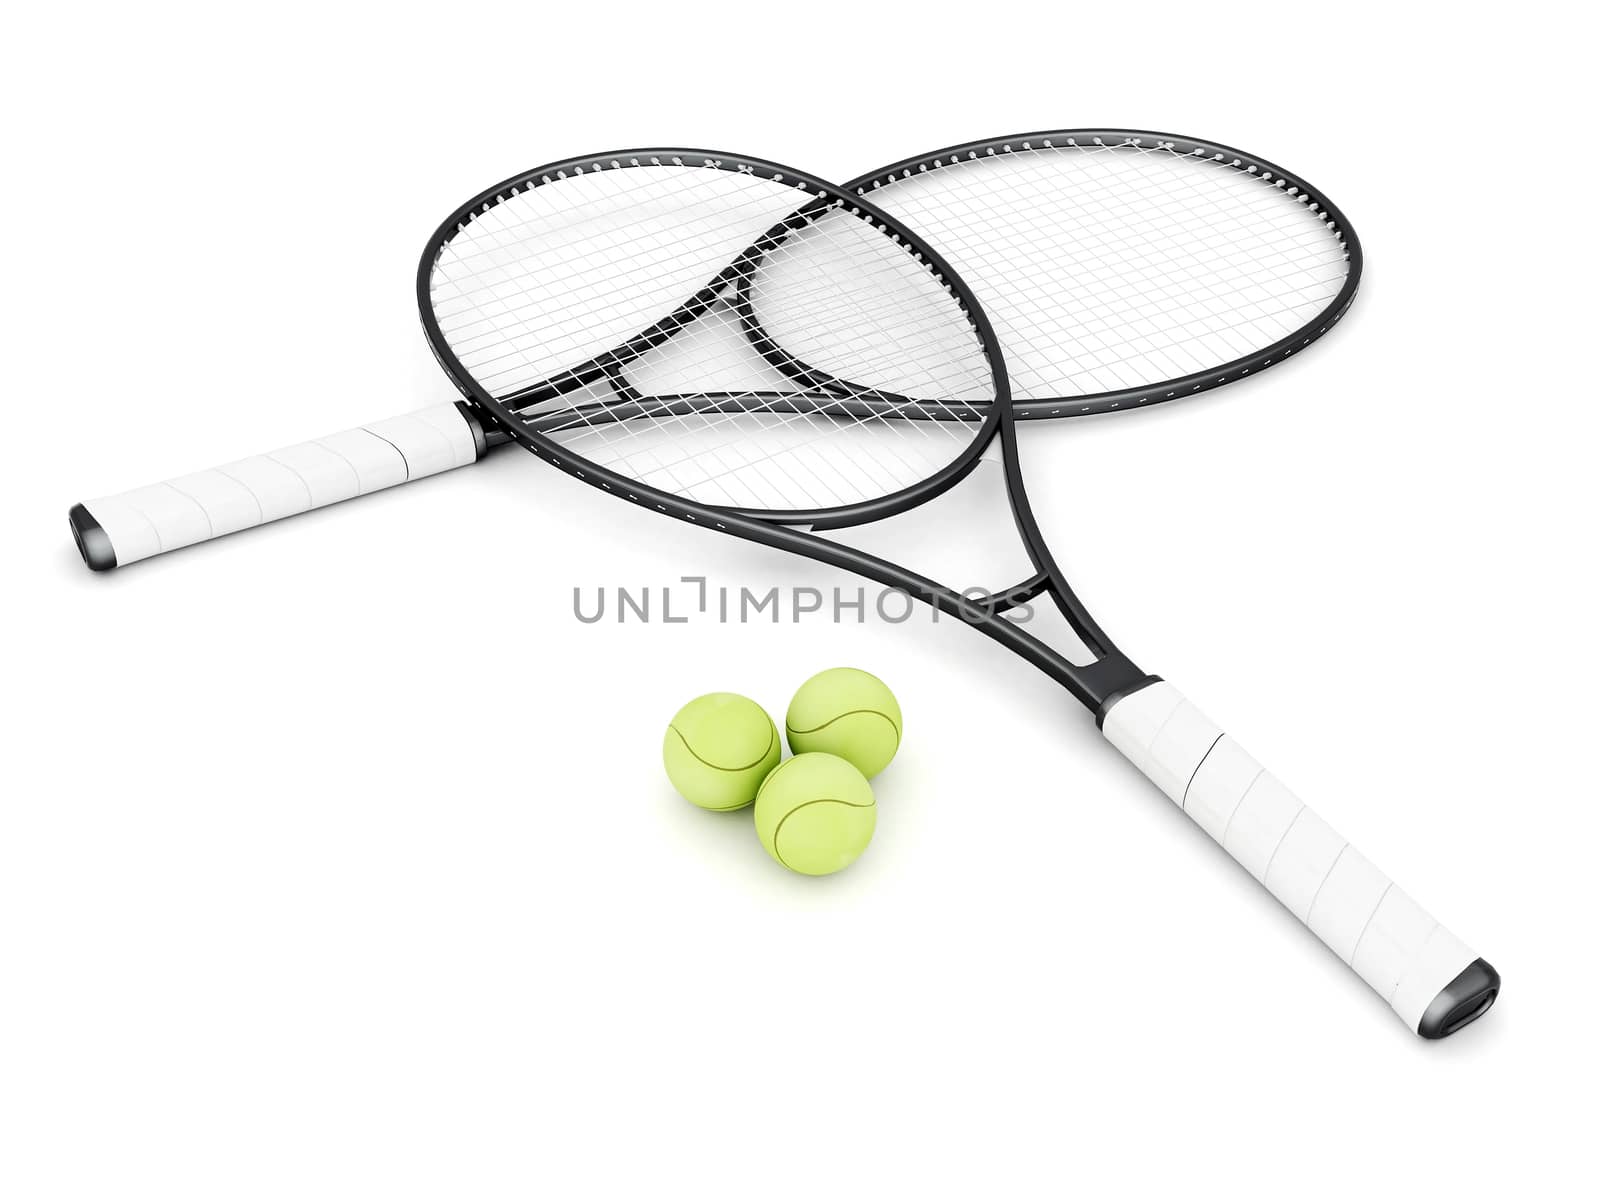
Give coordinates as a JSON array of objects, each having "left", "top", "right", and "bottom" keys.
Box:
[{"left": 416, "top": 149, "right": 1011, "bottom": 533}]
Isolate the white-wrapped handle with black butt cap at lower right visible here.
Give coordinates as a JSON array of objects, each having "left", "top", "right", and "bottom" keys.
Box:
[{"left": 1101, "top": 682, "right": 1499, "bottom": 1038}]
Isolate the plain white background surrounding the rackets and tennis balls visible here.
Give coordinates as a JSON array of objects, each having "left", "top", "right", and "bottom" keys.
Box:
[{"left": 0, "top": 3, "right": 1600, "bottom": 1200}]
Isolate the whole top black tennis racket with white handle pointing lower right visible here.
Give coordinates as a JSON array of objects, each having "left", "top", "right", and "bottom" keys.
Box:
[{"left": 380, "top": 150, "right": 1478, "bottom": 1038}]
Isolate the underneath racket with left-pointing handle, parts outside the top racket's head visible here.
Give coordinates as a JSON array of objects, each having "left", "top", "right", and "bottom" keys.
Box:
[{"left": 69, "top": 130, "right": 1362, "bottom": 570}]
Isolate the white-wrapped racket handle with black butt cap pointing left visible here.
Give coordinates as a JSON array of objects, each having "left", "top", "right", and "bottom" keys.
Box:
[{"left": 67, "top": 403, "right": 485, "bottom": 571}]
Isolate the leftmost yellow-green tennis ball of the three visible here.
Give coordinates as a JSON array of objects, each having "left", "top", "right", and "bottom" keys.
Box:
[{"left": 661, "top": 691, "right": 782, "bottom": 811}]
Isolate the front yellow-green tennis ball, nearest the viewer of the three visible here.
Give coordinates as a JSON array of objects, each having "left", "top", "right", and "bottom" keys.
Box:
[{"left": 755, "top": 754, "right": 878, "bottom": 875}]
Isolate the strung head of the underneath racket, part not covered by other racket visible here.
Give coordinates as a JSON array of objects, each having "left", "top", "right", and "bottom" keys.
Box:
[{"left": 843, "top": 130, "right": 1362, "bottom": 419}]
